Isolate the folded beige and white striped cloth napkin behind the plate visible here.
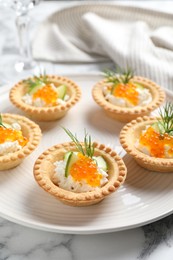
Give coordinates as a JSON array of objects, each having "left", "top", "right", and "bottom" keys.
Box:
[{"left": 33, "top": 4, "right": 173, "bottom": 90}]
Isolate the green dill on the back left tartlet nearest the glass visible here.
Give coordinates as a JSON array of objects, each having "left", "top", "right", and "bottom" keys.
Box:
[{"left": 24, "top": 71, "right": 49, "bottom": 93}]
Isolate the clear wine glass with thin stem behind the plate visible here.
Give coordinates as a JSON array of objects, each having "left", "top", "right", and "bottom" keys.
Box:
[{"left": 0, "top": 0, "right": 40, "bottom": 80}]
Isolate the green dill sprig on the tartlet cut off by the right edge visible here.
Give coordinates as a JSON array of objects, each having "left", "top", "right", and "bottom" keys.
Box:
[{"left": 158, "top": 102, "right": 173, "bottom": 135}]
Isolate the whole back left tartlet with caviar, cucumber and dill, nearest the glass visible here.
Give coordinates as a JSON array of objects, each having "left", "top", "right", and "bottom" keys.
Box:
[{"left": 10, "top": 74, "right": 81, "bottom": 121}]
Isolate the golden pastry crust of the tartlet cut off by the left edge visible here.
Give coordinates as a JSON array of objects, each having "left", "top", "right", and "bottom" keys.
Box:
[{"left": 0, "top": 113, "right": 41, "bottom": 171}]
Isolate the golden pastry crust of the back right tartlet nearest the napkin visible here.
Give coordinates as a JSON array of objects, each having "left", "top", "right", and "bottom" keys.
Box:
[{"left": 92, "top": 76, "right": 165, "bottom": 122}]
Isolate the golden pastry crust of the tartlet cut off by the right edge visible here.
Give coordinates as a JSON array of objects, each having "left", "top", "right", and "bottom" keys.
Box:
[{"left": 120, "top": 116, "right": 173, "bottom": 172}]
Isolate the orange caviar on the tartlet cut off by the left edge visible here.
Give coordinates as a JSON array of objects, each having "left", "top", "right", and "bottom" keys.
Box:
[{"left": 0, "top": 127, "right": 28, "bottom": 147}]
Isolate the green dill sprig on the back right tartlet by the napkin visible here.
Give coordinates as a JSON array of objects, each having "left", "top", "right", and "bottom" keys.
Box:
[{"left": 104, "top": 68, "right": 134, "bottom": 84}]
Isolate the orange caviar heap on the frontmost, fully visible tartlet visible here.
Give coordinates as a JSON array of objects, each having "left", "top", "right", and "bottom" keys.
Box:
[{"left": 70, "top": 154, "right": 102, "bottom": 187}]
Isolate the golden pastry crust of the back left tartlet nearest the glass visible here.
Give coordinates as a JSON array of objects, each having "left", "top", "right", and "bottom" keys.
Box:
[{"left": 9, "top": 75, "right": 81, "bottom": 121}]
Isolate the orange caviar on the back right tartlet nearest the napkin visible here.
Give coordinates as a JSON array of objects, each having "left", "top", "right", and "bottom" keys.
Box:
[{"left": 112, "top": 83, "right": 139, "bottom": 105}]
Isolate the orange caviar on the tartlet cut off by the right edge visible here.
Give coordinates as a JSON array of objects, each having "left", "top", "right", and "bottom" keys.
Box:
[{"left": 139, "top": 126, "right": 173, "bottom": 158}]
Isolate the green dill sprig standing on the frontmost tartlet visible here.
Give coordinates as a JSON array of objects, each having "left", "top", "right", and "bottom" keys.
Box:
[{"left": 63, "top": 127, "right": 94, "bottom": 158}]
